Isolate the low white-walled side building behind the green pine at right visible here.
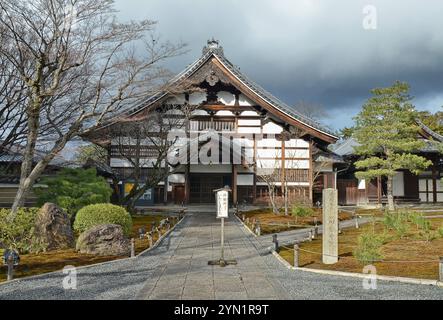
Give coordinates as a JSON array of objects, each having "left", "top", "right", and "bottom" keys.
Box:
[{"left": 334, "top": 120, "right": 443, "bottom": 205}]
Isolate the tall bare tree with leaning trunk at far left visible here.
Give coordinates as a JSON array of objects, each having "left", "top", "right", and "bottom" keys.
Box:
[{"left": 0, "top": 0, "right": 183, "bottom": 221}]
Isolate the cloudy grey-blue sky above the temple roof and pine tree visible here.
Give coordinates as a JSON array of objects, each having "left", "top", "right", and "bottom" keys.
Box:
[{"left": 112, "top": 0, "right": 443, "bottom": 129}]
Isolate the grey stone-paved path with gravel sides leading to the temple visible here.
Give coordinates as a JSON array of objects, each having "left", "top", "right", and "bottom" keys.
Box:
[{"left": 0, "top": 212, "right": 443, "bottom": 299}]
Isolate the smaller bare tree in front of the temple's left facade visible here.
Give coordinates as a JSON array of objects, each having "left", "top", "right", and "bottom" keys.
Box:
[{"left": 110, "top": 104, "right": 195, "bottom": 211}]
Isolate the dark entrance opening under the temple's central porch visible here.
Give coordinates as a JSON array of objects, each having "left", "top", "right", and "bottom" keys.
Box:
[{"left": 189, "top": 173, "right": 232, "bottom": 203}]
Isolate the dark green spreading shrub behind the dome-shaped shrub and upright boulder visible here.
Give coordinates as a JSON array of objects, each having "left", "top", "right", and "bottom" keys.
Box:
[{"left": 34, "top": 168, "right": 112, "bottom": 217}]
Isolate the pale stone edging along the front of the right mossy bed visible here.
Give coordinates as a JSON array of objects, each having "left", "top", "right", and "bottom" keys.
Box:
[{"left": 272, "top": 250, "right": 443, "bottom": 288}]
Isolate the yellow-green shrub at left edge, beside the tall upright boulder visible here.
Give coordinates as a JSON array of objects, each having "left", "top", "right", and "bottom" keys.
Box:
[{"left": 0, "top": 208, "right": 44, "bottom": 253}]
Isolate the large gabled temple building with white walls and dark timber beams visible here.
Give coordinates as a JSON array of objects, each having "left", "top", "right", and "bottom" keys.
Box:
[{"left": 84, "top": 40, "right": 341, "bottom": 206}]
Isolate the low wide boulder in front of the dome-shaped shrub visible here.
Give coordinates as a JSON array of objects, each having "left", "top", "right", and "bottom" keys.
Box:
[{"left": 76, "top": 224, "right": 131, "bottom": 256}]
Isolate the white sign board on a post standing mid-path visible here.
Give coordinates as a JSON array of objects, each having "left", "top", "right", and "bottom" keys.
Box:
[{"left": 208, "top": 186, "right": 237, "bottom": 267}]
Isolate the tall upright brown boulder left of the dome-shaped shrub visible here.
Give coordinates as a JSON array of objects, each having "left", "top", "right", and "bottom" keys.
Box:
[{"left": 33, "top": 202, "right": 74, "bottom": 251}]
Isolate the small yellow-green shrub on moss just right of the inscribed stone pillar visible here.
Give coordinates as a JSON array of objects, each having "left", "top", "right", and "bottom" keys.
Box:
[{"left": 354, "top": 232, "right": 384, "bottom": 264}]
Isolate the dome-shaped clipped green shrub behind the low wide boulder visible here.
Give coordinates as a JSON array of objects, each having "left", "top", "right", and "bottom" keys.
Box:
[{"left": 74, "top": 203, "right": 132, "bottom": 235}]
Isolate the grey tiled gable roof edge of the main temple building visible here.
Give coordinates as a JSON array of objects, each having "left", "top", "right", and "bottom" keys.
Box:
[{"left": 99, "top": 40, "right": 338, "bottom": 139}]
